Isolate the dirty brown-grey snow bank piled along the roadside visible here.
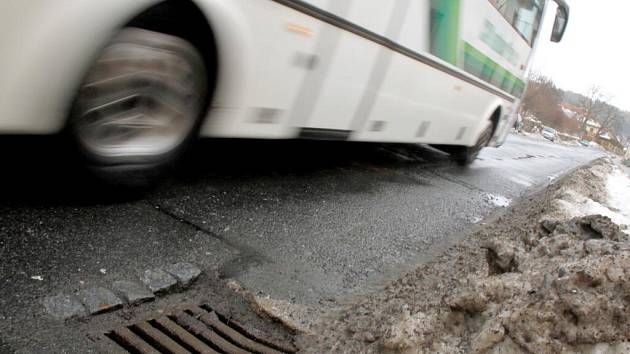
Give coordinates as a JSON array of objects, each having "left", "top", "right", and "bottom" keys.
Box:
[{"left": 300, "top": 159, "right": 630, "bottom": 354}]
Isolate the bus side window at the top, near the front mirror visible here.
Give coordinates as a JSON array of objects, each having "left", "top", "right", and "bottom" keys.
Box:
[{"left": 489, "top": 0, "right": 543, "bottom": 45}]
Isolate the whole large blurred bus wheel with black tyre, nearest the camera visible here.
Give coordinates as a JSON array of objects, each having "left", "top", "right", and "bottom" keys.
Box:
[{"left": 68, "top": 27, "right": 208, "bottom": 186}]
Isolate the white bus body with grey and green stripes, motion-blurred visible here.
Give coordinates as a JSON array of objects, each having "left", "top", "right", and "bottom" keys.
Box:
[{"left": 0, "top": 0, "right": 568, "bottom": 176}]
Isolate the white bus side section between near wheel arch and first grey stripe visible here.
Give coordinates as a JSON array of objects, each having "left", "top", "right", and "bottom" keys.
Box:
[{"left": 200, "top": 0, "right": 328, "bottom": 139}]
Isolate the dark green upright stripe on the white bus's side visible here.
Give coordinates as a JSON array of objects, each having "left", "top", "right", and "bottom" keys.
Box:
[{"left": 431, "top": 0, "right": 460, "bottom": 65}]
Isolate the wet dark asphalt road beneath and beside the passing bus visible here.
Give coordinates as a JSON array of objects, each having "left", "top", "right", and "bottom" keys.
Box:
[{"left": 0, "top": 136, "right": 603, "bottom": 352}]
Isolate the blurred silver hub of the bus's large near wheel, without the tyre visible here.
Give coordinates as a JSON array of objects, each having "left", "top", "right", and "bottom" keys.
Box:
[{"left": 74, "top": 28, "right": 201, "bottom": 158}]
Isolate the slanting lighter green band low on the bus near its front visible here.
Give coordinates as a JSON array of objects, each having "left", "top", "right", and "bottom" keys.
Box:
[{"left": 464, "top": 42, "right": 525, "bottom": 97}]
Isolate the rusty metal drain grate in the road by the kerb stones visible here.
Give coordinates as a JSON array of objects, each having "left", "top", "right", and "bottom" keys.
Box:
[{"left": 102, "top": 305, "right": 296, "bottom": 354}]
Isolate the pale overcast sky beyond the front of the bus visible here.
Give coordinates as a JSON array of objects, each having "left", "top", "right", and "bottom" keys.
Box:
[{"left": 533, "top": 0, "right": 630, "bottom": 111}]
